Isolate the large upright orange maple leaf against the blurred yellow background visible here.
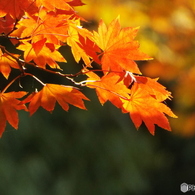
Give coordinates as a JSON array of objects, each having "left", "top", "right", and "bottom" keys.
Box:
[{"left": 94, "top": 18, "right": 151, "bottom": 74}]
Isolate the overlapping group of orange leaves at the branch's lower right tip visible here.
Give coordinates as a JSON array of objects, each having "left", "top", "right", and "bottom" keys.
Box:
[{"left": 87, "top": 73, "right": 176, "bottom": 135}]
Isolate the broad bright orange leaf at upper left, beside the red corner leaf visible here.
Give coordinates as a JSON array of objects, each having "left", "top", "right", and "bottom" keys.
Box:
[{"left": 10, "top": 8, "right": 70, "bottom": 45}]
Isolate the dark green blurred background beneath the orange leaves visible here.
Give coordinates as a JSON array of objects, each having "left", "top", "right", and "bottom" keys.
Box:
[{"left": 0, "top": 0, "right": 195, "bottom": 195}]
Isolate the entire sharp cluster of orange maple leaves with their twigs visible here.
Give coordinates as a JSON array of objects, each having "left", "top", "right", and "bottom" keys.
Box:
[{"left": 0, "top": 0, "right": 176, "bottom": 135}]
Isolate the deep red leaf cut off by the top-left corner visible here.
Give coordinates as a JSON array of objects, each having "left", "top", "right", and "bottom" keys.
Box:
[{"left": 0, "top": 0, "right": 34, "bottom": 18}]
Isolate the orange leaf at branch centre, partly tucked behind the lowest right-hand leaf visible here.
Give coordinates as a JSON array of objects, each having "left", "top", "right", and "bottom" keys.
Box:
[{"left": 86, "top": 72, "right": 130, "bottom": 108}]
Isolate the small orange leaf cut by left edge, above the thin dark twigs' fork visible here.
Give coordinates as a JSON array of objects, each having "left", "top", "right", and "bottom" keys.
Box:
[{"left": 0, "top": 49, "right": 19, "bottom": 79}]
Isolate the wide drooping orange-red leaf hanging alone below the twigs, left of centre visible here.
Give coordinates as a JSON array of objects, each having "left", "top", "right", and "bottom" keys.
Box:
[{"left": 23, "top": 84, "right": 89, "bottom": 115}]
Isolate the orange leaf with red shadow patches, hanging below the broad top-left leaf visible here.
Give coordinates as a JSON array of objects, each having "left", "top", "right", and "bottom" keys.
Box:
[{"left": 18, "top": 42, "right": 66, "bottom": 69}]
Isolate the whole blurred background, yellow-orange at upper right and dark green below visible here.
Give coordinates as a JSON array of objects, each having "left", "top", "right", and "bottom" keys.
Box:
[{"left": 0, "top": 0, "right": 195, "bottom": 195}]
